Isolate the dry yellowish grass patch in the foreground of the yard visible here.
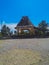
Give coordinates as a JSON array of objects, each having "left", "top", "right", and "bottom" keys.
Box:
[{"left": 0, "top": 49, "right": 43, "bottom": 65}]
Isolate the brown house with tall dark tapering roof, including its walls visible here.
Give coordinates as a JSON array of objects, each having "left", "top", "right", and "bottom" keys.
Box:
[{"left": 15, "top": 16, "right": 35, "bottom": 35}]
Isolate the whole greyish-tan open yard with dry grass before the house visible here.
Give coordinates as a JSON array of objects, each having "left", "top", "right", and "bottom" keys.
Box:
[{"left": 0, "top": 38, "right": 49, "bottom": 65}]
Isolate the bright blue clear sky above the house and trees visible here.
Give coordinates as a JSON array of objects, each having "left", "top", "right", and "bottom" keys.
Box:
[{"left": 0, "top": 0, "right": 49, "bottom": 26}]
